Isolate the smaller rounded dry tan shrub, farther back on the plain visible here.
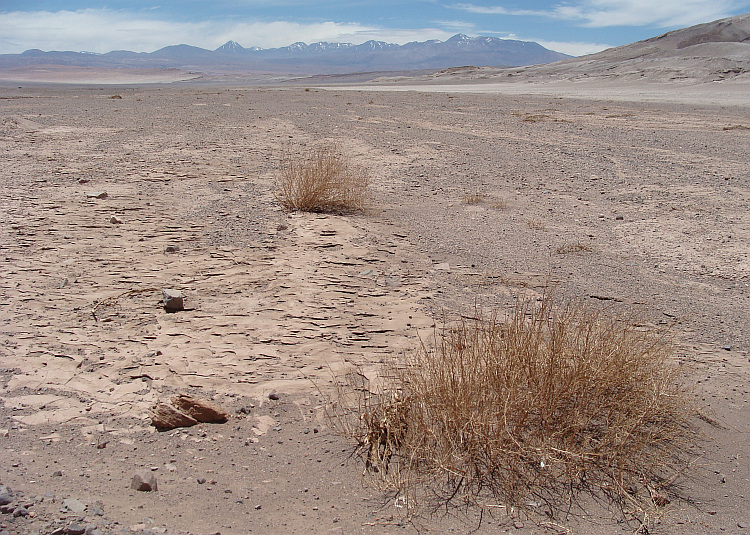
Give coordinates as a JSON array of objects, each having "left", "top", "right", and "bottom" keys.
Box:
[{"left": 275, "top": 146, "right": 368, "bottom": 213}]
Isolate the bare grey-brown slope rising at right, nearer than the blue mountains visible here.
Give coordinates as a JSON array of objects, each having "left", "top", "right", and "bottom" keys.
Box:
[{"left": 428, "top": 13, "right": 750, "bottom": 83}]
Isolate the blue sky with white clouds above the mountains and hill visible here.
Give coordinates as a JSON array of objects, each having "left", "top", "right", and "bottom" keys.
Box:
[{"left": 0, "top": 0, "right": 750, "bottom": 55}]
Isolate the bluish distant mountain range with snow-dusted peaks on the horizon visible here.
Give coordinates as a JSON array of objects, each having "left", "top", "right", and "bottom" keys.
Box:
[{"left": 0, "top": 34, "right": 570, "bottom": 74}]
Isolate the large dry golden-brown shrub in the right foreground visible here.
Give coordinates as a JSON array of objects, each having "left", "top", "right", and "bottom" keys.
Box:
[{"left": 329, "top": 297, "right": 694, "bottom": 521}]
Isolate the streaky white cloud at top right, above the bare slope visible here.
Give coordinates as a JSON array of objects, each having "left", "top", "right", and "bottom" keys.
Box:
[{"left": 452, "top": 0, "right": 750, "bottom": 28}]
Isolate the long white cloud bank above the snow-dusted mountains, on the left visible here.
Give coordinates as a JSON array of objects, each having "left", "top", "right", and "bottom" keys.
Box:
[{"left": 0, "top": 9, "right": 455, "bottom": 54}]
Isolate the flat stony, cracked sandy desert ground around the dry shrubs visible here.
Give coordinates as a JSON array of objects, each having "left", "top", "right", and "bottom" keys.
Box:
[{"left": 0, "top": 80, "right": 750, "bottom": 535}]
